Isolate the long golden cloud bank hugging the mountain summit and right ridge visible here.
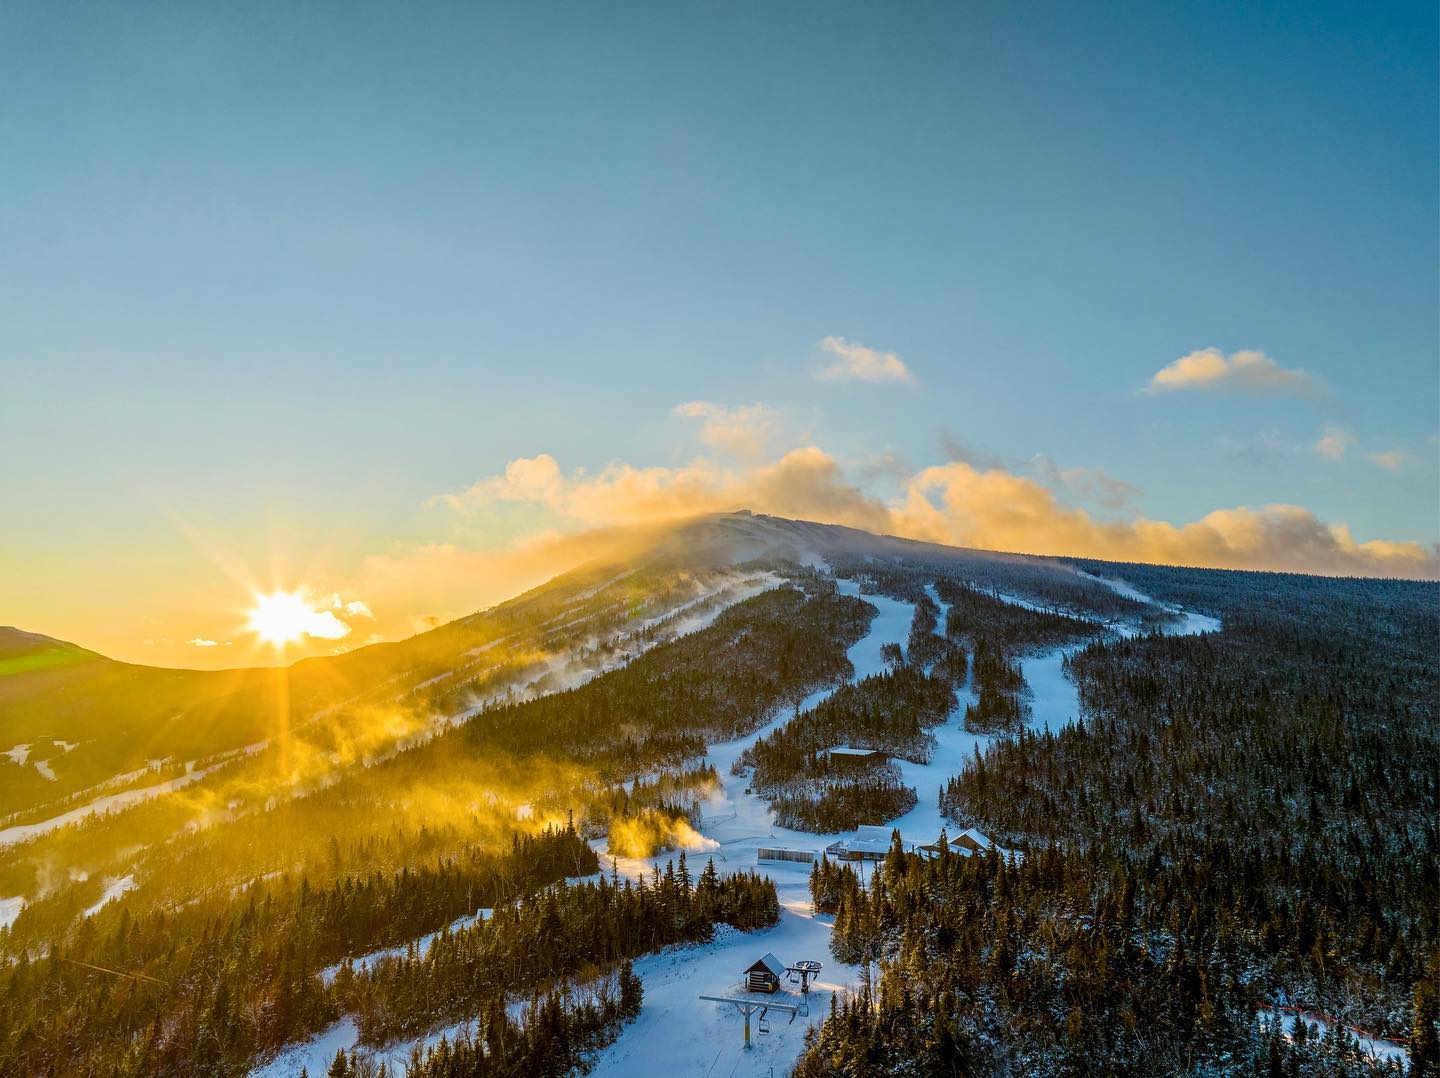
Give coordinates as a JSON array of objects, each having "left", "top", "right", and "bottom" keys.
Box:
[{"left": 434, "top": 446, "right": 1440, "bottom": 586}]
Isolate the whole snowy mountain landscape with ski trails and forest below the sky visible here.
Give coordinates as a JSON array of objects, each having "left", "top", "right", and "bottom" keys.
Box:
[{"left": 0, "top": 512, "right": 1440, "bottom": 1075}]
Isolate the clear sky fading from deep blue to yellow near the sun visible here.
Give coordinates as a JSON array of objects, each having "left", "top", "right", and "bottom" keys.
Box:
[{"left": 0, "top": 3, "right": 1440, "bottom": 662}]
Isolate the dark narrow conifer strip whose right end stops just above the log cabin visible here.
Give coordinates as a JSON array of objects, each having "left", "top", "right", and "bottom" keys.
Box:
[{"left": 334, "top": 853, "right": 779, "bottom": 1045}]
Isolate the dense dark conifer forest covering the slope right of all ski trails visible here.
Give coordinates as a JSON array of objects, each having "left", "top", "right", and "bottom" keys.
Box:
[{"left": 796, "top": 567, "right": 1440, "bottom": 1077}]
